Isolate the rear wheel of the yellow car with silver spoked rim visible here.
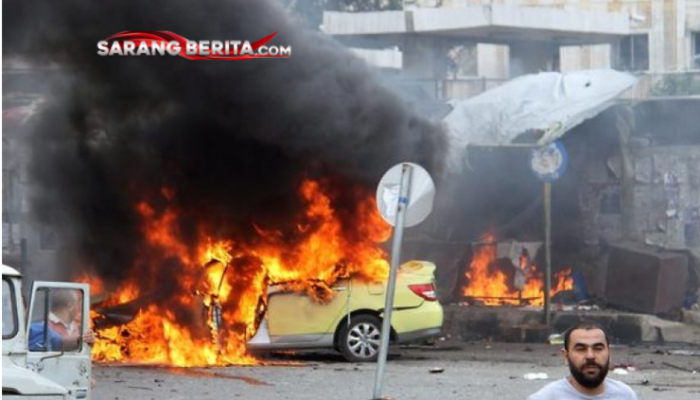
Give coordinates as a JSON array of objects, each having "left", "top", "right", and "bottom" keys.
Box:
[{"left": 338, "top": 315, "right": 382, "bottom": 362}]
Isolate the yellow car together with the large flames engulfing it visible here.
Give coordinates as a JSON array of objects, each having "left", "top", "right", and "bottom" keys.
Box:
[{"left": 86, "top": 179, "right": 432, "bottom": 367}]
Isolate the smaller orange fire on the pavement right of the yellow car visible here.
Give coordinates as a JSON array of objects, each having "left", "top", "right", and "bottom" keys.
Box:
[{"left": 462, "top": 234, "right": 573, "bottom": 306}]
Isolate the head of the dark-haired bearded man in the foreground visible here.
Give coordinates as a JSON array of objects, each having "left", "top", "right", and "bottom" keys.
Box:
[{"left": 564, "top": 329, "right": 610, "bottom": 389}]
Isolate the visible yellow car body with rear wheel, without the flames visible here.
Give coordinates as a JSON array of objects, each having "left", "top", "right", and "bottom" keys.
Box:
[{"left": 247, "top": 261, "right": 443, "bottom": 362}]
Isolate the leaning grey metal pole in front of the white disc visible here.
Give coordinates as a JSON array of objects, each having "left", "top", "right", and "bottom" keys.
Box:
[{"left": 372, "top": 164, "right": 413, "bottom": 400}]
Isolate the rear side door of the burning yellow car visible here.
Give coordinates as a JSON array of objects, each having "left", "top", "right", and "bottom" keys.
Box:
[{"left": 267, "top": 280, "right": 350, "bottom": 343}]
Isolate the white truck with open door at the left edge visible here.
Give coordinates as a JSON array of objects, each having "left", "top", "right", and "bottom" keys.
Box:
[{"left": 1, "top": 264, "right": 92, "bottom": 400}]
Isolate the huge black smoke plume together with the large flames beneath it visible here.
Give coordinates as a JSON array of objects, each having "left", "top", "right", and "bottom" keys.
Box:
[{"left": 2, "top": 0, "right": 445, "bottom": 366}]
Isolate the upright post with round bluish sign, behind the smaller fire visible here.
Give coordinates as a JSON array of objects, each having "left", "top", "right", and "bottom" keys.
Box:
[{"left": 530, "top": 141, "right": 569, "bottom": 326}]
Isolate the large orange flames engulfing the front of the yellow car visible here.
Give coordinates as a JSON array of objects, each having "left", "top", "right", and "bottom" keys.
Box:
[{"left": 87, "top": 180, "right": 391, "bottom": 366}]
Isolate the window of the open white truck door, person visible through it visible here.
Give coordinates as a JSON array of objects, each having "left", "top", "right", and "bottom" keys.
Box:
[{"left": 29, "top": 288, "right": 83, "bottom": 352}]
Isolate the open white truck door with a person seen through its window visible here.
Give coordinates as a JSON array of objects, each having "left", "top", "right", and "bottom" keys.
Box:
[{"left": 27, "top": 282, "right": 92, "bottom": 399}]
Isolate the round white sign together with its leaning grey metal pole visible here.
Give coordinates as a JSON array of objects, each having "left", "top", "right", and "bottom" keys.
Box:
[{"left": 372, "top": 163, "right": 435, "bottom": 399}]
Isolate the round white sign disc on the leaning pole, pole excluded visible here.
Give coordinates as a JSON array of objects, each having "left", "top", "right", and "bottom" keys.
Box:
[{"left": 377, "top": 163, "right": 435, "bottom": 227}]
